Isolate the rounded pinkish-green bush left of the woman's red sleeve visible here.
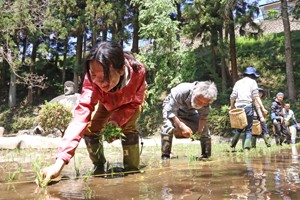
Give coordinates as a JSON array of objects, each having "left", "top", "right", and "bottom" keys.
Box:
[{"left": 38, "top": 102, "right": 72, "bottom": 134}]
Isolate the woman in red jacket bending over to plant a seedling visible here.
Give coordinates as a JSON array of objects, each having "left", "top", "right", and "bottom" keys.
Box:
[{"left": 41, "top": 42, "right": 147, "bottom": 183}]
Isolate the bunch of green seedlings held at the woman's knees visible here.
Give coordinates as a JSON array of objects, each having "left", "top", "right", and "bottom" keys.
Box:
[{"left": 101, "top": 123, "right": 126, "bottom": 142}]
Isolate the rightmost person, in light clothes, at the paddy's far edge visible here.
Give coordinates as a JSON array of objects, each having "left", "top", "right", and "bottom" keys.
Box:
[{"left": 282, "top": 103, "right": 300, "bottom": 144}]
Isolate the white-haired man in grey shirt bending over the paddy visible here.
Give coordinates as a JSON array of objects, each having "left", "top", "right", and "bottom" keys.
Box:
[{"left": 161, "top": 81, "right": 218, "bottom": 160}]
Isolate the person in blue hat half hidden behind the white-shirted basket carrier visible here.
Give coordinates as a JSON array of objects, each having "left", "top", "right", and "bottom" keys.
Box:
[{"left": 252, "top": 88, "right": 271, "bottom": 148}]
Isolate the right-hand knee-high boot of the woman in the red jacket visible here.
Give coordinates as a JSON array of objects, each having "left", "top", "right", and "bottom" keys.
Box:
[{"left": 122, "top": 133, "right": 140, "bottom": 171}]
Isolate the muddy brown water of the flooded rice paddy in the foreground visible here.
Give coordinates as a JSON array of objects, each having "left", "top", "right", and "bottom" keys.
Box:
[{"left": 0, "top": 145, "right": 300, "bottom": 200}]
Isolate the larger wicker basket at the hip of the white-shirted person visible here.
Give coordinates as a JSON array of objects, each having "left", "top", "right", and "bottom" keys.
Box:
[{"left": 229, "top": 108, "right": 248, "bottom": 129}]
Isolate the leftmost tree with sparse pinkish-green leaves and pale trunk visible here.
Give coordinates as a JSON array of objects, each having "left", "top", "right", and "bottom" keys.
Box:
[{"left": 0, "top": 0, "right": 48, "bottom": 107}]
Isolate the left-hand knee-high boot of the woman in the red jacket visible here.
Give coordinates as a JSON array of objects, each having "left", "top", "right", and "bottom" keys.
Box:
[{"left": 84, "top": 136, "right": 106, "bottom": 174}]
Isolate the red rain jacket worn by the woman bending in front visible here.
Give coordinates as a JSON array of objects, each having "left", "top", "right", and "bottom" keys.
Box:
[{"left": 57, "top": 62, "right": 147, "bottom": 163}]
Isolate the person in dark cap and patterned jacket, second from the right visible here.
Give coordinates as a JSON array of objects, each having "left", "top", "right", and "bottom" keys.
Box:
[{"left": 271, "top": 92, "right": 291, "bottom": 145}]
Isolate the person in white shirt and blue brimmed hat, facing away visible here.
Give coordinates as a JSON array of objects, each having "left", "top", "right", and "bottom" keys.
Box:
[{"left": 229, "top": 66, "right": 268, "bottom": 151}]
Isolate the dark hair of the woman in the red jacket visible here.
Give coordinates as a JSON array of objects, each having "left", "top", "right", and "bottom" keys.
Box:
[{"left": 84, "top": 41, "right": 141, "bottom": 82}]
